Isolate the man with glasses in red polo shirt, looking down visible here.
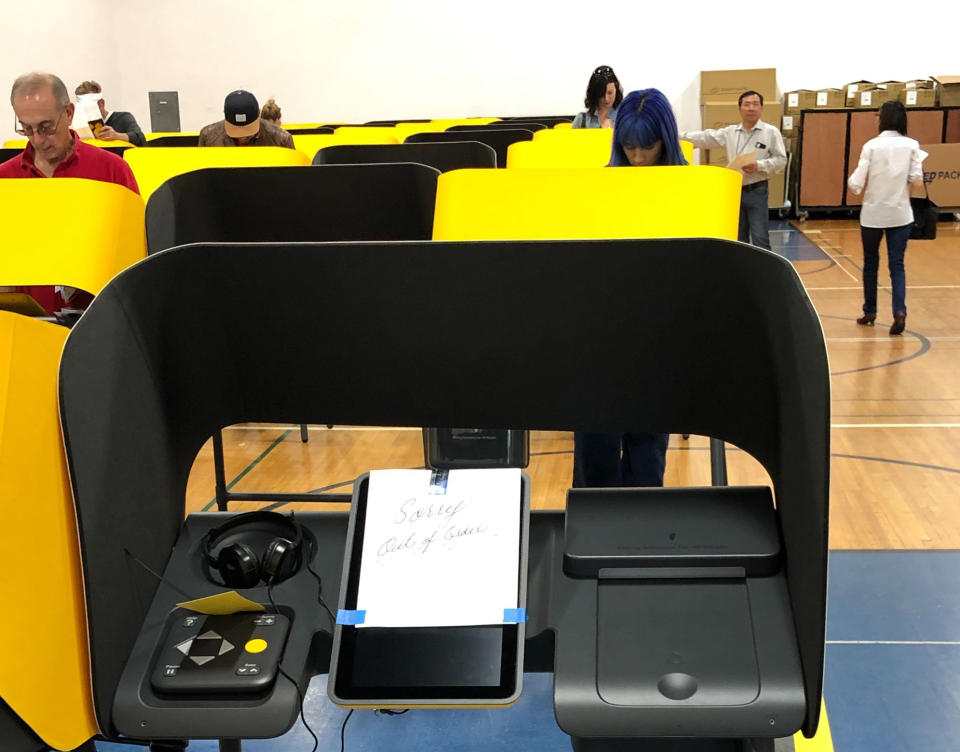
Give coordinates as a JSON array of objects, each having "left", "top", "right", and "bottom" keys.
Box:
[{"left": 0, "top": 73, "right": 140, "bottom": 314}]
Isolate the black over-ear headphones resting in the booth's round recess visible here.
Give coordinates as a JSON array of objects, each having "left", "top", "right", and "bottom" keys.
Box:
[{"left": 200, "top": 512, "right": 304, "bottom": 588}]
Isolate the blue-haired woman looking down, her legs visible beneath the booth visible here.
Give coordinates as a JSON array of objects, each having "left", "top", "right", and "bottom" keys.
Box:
[{"left": 573, "top": 89, "right": 687, "bottom": 488}]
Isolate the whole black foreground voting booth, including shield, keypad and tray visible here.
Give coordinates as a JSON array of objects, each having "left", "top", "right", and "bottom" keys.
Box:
[{"left": 59, "top": 238, "right": 829, "bottom": 752}]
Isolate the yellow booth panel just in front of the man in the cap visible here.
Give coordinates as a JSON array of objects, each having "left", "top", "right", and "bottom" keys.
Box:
[{"left": 123, "top": 146, "right": 310, "bottom": 201}]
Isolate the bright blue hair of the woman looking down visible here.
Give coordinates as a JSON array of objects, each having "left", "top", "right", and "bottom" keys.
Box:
[{"left": 607, "top": 89, "right": 687, "bottom": 167}]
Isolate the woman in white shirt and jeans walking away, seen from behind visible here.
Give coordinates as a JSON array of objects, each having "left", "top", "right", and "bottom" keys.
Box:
[{"left": 847, "top": 102, "right": 927, "bottom": 334}]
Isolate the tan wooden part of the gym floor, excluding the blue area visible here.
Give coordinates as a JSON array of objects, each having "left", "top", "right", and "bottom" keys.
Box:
[{"left": 187, "top": 220, "right": 960, "bottom": 549}]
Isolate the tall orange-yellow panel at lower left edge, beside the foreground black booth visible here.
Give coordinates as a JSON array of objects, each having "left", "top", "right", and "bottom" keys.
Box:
[{"left": 0, "top": 310, "right": 98, "bottom": 749}]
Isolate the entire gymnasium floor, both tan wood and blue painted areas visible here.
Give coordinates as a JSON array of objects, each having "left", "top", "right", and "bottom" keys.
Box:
[{"left": 98, "top": 220, "right": 960, "bottom": 752}]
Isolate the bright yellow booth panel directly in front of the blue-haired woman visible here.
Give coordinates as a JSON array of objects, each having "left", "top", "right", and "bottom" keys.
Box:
[{"left": 433, "top": 166, "right": 741, "bottom": 240}]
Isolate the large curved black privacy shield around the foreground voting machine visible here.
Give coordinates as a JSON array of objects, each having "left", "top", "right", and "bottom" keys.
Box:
[{"left": 60, "top": 239, "right": 829, "bottom": 731}]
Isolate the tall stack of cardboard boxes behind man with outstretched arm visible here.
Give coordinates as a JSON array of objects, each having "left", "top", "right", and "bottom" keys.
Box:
[{"left": 700, "top": 68, "right": 784, "bottom": 208}]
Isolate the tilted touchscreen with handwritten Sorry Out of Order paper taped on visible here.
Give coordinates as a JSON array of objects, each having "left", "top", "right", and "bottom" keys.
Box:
[{"left": 327, "top": 468, "right": 530, "bottom": 707}]
